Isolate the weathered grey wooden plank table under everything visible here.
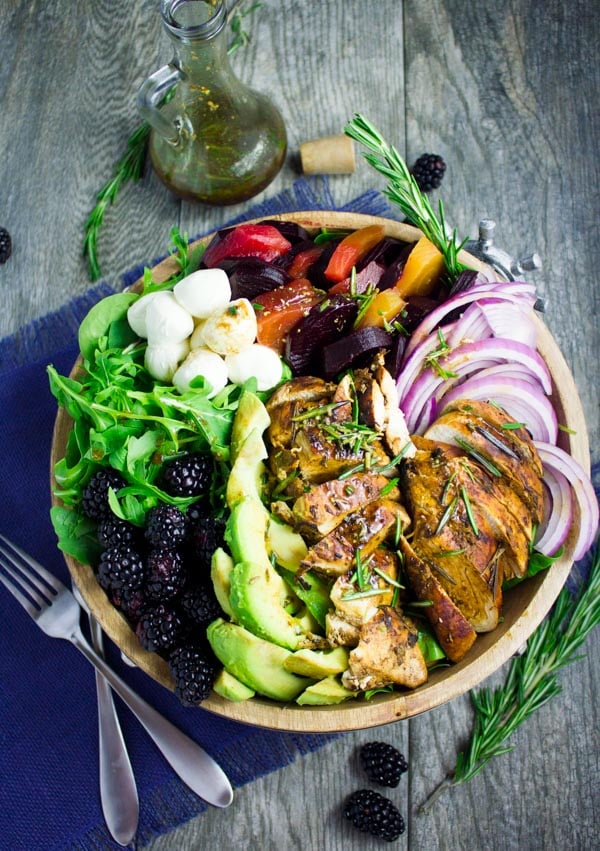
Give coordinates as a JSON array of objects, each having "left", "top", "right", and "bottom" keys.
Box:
[{"left": 0, "top": 0, "right": 600, "bottom": 851}]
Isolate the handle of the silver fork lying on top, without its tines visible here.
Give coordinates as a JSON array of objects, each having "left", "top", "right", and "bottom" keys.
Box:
[{"left": 70, "top": 630, "right": 233, "bottom": 807}]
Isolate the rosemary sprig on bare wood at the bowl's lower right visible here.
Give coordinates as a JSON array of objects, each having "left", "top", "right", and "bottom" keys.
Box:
[{"left": 419, "top": 542, "right": 600, "bottom": 813}]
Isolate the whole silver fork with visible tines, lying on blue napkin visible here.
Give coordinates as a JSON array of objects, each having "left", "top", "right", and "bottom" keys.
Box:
[{"left": 0, "top": 535, "right": 233, "bottom": 807}]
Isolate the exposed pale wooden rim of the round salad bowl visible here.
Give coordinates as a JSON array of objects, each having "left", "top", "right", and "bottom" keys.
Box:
[{"left": 51, "top": 212, "right": 590, "bottom": 733}]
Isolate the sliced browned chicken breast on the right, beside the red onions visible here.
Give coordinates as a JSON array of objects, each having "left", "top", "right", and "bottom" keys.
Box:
[{"left": 400, "top": 401, "right": 543, "bottom": 661}]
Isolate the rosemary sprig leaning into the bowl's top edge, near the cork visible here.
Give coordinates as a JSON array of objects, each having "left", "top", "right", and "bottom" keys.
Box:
[{"left": 344, "top": 113, "right": 467, "bottom": 279}]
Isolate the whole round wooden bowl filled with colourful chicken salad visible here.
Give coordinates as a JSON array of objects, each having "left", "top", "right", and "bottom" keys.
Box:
[{"left": 48, "top": 120, "right": 598, "bottom": 731}]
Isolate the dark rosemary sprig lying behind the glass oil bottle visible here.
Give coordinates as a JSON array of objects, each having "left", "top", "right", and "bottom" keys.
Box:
[{"left": 83, "top": 2, "right": 262, "bottom": 281}]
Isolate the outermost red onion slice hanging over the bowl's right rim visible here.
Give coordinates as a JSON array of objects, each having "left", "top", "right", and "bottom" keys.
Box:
[{"left": 534, "top": 441, "right": 599, "bottom": 561}]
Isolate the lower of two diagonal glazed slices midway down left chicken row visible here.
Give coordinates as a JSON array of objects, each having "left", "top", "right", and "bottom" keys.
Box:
[{"left": 300, "top": 499, "right": 408, "bottom": 576}]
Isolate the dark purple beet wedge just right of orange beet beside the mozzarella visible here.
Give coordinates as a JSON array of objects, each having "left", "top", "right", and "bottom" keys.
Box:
[{"left": 285, "top": 295, "right": 358, "bottom": 375}]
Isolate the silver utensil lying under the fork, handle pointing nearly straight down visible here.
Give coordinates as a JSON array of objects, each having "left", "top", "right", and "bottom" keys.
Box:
[{"left": 73, "top": 585, "right": 139, "bottom": 847}]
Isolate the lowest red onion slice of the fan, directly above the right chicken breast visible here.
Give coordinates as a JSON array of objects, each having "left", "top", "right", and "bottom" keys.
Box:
[{"left": 438, "top": 375, "right": 558, "bottom": 443}]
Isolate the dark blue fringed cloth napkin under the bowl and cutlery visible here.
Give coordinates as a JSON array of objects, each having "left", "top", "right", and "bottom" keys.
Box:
[{"left": 0, "top": 178, "right": 393, "bottom": 851}]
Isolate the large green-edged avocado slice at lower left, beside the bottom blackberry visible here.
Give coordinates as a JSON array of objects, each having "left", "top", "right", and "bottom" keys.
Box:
[{"left": 206, "top": 618, "right": 311, "bottom": 701}]
